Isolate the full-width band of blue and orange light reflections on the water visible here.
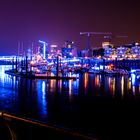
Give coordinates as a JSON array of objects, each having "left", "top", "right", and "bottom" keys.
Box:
[{"left": 0, "top": 66, "right": 140, "bottom": 118}]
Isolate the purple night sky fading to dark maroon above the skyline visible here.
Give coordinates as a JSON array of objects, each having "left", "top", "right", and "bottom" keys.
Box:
[{"left": 0, "top": 0, "right": 140, "bottom": 55}]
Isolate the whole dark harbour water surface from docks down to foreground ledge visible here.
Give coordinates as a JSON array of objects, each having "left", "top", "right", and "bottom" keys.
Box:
[{"left": 0, "top": 66, "right": 140, "bottom": 140}]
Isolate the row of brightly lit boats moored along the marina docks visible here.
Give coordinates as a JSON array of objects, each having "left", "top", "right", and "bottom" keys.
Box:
[{"left": 27, "top": 59, "right": 140, "bottom": 77}]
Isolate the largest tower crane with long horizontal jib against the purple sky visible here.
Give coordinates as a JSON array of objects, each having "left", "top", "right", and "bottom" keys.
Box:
[{"left": 80, "top": 32, "right": 112, "bottom": 50}]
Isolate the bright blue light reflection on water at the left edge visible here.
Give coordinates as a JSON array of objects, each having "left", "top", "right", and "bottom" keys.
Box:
[{"left": 0, "top": 65, "right": 18, "bottom": 110}]
